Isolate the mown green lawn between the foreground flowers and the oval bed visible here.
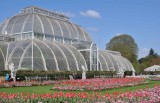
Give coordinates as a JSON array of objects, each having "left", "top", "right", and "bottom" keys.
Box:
[{"left": 0, "top": 81, "right": 160, "bottom": 94}]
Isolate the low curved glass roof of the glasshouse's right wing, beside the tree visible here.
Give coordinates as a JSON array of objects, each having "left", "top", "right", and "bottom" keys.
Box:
[{"left": 98, "top": 50, "right": 135, "bottom": 72}]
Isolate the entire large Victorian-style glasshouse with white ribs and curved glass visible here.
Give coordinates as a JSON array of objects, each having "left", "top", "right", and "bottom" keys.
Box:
[{"left": 0, "top": 6, "right": 135, "bottom": 73}]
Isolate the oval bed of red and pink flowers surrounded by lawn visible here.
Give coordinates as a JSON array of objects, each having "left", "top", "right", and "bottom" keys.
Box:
[{"left": 52, "top": 77, "right": 147, "bottom": 90}]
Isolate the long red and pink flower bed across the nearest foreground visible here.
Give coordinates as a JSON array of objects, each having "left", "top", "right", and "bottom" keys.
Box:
[{"left": 0, "top": 85, "right": 160, "bottom": 103}]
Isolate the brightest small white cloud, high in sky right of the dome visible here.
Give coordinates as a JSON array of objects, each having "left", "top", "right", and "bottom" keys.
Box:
[{"left": 80, "top": 10, "right": 101, "bottom": 18}]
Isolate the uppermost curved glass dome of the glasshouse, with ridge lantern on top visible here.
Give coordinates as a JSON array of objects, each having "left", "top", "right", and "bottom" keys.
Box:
[{"left": 0, "top": 7, "right": 92, "bottom": 43}]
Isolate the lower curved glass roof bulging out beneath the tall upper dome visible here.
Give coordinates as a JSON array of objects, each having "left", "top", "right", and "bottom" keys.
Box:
[{"left": 1, "top": 40, "right": 87, "bottom": 71}]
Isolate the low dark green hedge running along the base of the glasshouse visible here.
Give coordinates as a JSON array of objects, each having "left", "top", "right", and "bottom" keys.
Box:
[{"left": 0, "top": 70, "right": 116, "bottom": 80}]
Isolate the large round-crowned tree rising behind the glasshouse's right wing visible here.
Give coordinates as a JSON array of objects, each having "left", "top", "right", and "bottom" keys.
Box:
[{"left": 106, "top": 34, "right": 138, "bottom": 62}]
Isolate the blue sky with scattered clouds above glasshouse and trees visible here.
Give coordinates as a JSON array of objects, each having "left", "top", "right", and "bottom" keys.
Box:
[{"left": 0, "top": 0, "right": 160, "bottom": 58}]
